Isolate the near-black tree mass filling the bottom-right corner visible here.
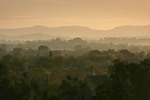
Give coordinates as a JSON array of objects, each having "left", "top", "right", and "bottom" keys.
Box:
[{"left": 93, "top": 59, "right": 150, "bottom": 100}]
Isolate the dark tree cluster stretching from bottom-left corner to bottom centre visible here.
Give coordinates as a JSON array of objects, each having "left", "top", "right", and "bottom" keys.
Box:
[{"left": 0, "top": 61, "right": 91, "bottom": 100}]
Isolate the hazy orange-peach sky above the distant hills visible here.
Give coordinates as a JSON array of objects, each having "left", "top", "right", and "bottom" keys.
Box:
[{"left": 0, "top": 0, "right": 150, "bottom": 29}]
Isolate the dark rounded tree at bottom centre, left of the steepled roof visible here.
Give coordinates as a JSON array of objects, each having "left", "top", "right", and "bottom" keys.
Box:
[{"left": 50, "top": 76, "right": 91, "bottom": 100}]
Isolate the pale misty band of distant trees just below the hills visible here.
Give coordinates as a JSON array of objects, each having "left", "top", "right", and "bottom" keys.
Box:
[{"left": 0, "top": 38, "right": 150, "bottom": 54}]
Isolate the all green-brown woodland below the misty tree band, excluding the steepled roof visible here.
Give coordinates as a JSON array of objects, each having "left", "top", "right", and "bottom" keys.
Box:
[{"left": 0, "top": 46, "right": 150, "bottom": 100}]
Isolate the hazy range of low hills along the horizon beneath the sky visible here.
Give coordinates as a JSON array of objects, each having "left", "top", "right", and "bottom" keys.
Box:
[{"left": 0, "top": 25, "right": 150, "bottom": 39}]
